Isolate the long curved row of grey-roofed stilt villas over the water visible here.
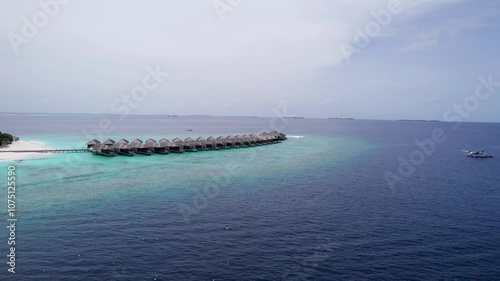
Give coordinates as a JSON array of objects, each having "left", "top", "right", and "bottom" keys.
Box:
[{"left": 87, "top": 131, "right": 286, "bottom": 156}]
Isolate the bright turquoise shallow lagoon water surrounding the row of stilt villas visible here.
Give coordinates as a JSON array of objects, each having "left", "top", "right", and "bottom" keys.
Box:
[{"left": 3, "top": 132, "right": 370, "bottom": 214}]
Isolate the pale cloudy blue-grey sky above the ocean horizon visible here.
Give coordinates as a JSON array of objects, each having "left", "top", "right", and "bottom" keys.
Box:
[{"left": 0, "top": 0, "right": 500, "bottom": 122}]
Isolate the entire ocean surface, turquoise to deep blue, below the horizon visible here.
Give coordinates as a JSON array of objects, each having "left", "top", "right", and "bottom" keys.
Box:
[{"left": 0, "top": 114, "right": 500, "bottom": 280}]
